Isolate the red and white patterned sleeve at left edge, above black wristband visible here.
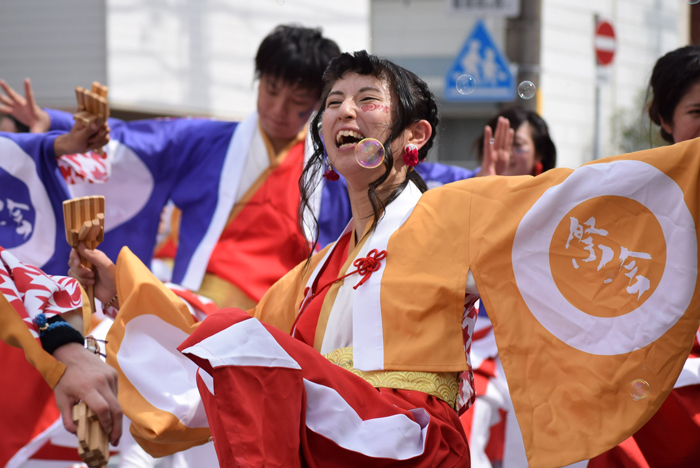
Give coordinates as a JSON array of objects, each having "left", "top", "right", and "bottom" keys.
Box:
[{"left": 0, "top": 247, "right": 83, "bottom": 339}]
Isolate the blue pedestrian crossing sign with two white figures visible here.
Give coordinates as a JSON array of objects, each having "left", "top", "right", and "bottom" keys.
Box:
[{"left": 444, "top": 20, "right": 515, "bottom": 102}]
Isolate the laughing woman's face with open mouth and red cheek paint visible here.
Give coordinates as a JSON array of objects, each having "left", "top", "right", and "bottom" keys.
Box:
[{"left": 322, "top": 73, "right": 402, "bottom": 184}]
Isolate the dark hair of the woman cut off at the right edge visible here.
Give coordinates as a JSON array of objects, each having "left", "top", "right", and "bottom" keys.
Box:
[{"left": 647, "top": 46, "right": 700, "bottom": 143}]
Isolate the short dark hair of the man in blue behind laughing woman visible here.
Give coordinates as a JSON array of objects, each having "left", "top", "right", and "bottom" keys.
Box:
[{"left": 255, "top": 26, "right": 340, "bottom": 94}]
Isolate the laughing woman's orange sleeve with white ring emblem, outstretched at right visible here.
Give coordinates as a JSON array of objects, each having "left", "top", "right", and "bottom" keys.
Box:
[{"left": 381, "top": 139, "right": 700, "bottom": 467}]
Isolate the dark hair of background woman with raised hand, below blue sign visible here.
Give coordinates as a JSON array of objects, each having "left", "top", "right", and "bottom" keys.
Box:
[{"left": 474, "top": 107, "right": 557, "bottom": 175}]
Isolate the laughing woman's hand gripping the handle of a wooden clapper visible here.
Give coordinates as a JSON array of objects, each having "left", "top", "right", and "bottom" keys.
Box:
[{"left": 68, "top": 242, "right": 119, "bottom": 309}]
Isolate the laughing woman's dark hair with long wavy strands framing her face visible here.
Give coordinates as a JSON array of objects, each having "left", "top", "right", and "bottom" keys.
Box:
[{"left": 299, "top": 50, "right": 439, "bottom": 250}]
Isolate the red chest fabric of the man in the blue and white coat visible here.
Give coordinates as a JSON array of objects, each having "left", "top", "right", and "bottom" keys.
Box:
[{"left": 207, "top": 141, "right": 308, "bottom": 301}]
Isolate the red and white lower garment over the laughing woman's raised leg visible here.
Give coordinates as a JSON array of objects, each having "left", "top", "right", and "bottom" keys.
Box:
[{"left": 178, "top": 309, "right": 469, "bottom": 468}]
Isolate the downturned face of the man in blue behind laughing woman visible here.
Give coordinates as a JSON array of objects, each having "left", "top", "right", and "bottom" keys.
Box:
[{"left": 258, "top": 75, "right": 319, "bottom": 140}]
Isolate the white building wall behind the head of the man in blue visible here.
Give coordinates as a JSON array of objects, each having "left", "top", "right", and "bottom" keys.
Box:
[{"left": 107, "top": 0, "right": 369, "bottom": 118}]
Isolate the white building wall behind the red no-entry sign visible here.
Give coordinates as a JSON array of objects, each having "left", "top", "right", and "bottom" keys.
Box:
[{"left": 539, "top": 0, "right": 689, "bottom": 167}]
